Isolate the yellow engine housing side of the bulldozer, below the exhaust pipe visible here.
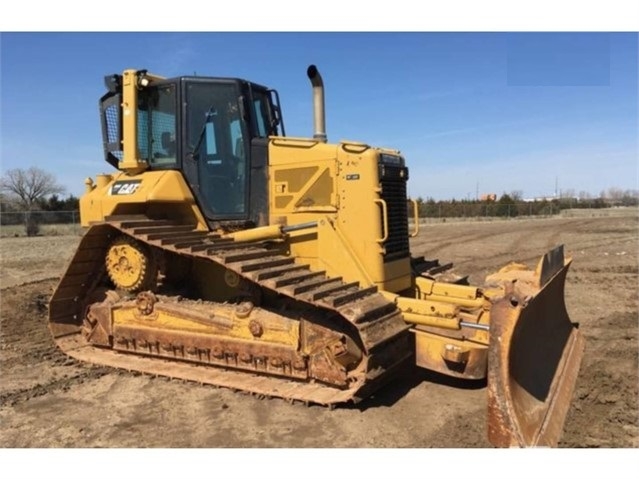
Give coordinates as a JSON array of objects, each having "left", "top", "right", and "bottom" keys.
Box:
[{"left": 269, "top": 138, "right": 412, "bottom": 291}]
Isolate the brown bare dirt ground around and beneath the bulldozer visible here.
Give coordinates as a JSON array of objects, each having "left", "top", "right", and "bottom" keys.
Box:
[{"left": 0, "top": 210, "right": 639, "bottom": 448}]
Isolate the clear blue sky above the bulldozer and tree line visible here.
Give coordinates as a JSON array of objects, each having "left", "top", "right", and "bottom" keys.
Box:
[{"left": 0, "top": 33, "right": 639, "bottom": 199}]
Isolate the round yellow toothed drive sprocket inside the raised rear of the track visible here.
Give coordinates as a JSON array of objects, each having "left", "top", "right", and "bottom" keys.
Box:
[{"left": 105, "top": 236, "right": 158, "bottom": 293}]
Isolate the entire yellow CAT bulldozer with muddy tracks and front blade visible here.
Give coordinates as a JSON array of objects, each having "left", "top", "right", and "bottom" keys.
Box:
[{"left": 49, "top": 65, "right": 583, "bottom": 447}]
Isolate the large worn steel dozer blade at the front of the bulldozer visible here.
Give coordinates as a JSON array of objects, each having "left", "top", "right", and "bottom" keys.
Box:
[{"left": 488, "top": 245, "right": 584, "bottom": 447}]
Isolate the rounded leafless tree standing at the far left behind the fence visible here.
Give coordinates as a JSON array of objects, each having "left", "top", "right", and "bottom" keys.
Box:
[{"left": 0, "top": 166, "right": 65, "bottom": 236}]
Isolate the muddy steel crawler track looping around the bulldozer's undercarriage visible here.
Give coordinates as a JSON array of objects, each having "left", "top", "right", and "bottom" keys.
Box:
[{"left": 49, "top": 217, "right": 412, "bottom": 405}]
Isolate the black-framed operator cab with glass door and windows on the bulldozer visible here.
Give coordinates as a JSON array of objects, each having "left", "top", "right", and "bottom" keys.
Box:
[{"left": 101, "top": 71, "right": 284, "bottom": 226}]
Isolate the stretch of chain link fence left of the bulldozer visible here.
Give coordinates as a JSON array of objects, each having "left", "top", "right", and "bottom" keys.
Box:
[{"left": 0, "top": 211, "right": 82, "bottom": 237}]
